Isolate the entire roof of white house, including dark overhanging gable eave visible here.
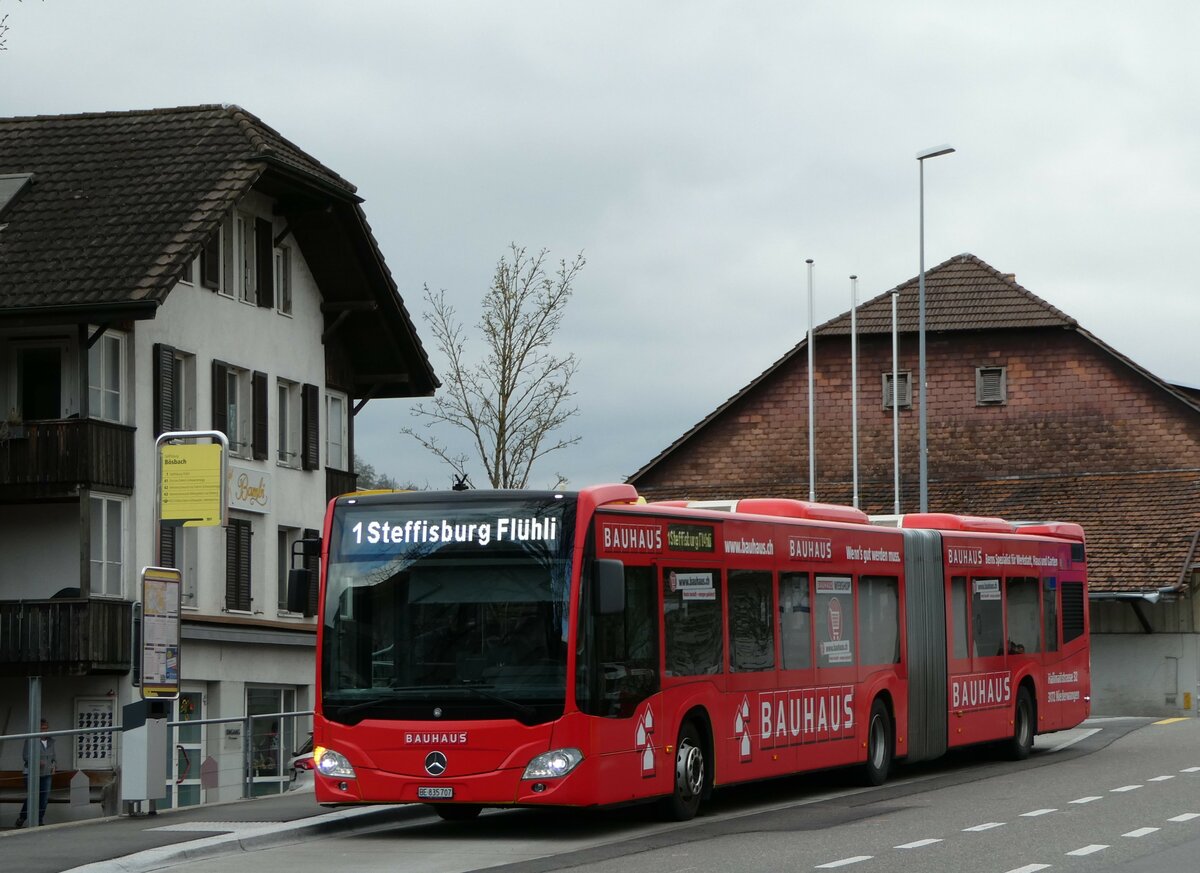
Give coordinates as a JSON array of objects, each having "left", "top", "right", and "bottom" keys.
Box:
[{"left": 0, "top": 106, "right": 438, "bottom": 397}]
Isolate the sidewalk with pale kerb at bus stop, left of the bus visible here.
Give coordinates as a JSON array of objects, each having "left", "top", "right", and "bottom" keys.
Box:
[{"left": 0, "top": 790, "right": 427, "bottom": 873}]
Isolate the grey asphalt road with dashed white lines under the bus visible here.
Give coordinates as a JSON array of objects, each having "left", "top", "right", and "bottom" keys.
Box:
[{"left": 108, "top": 720, "right": 1200, "bottom": 873}]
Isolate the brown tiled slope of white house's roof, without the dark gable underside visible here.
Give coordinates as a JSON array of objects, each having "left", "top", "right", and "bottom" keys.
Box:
[{"left": 0, "top": 106, "right": 356, "bottom": 314}]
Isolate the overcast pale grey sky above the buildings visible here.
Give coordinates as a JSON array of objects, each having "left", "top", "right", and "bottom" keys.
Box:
[{"left": 0, "top": 0, "right": 1200, "bottom": 487}]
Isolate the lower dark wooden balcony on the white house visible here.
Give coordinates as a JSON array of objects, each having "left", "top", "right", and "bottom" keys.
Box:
[{"left": 0, "top": 597, "right": 133, "bottom": 676}]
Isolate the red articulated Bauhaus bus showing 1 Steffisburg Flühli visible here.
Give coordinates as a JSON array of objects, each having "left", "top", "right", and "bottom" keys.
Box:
[{"left": 292, "top": 484, "right": 1090, "bottom": 820}]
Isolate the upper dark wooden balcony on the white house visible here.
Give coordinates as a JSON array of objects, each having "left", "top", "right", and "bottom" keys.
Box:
[{"left": 0, "top": 419, "right": 134, "bottom": 502}]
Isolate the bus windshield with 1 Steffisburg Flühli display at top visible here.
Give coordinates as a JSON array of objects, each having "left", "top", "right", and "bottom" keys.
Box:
[{"left": 320, "top": 493, "right": 574, "bottom": 724}]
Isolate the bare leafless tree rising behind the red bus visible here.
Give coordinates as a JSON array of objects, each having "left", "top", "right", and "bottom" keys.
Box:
[{"left": 401, "top": 243, "right": 587, "bottom": 488}]
